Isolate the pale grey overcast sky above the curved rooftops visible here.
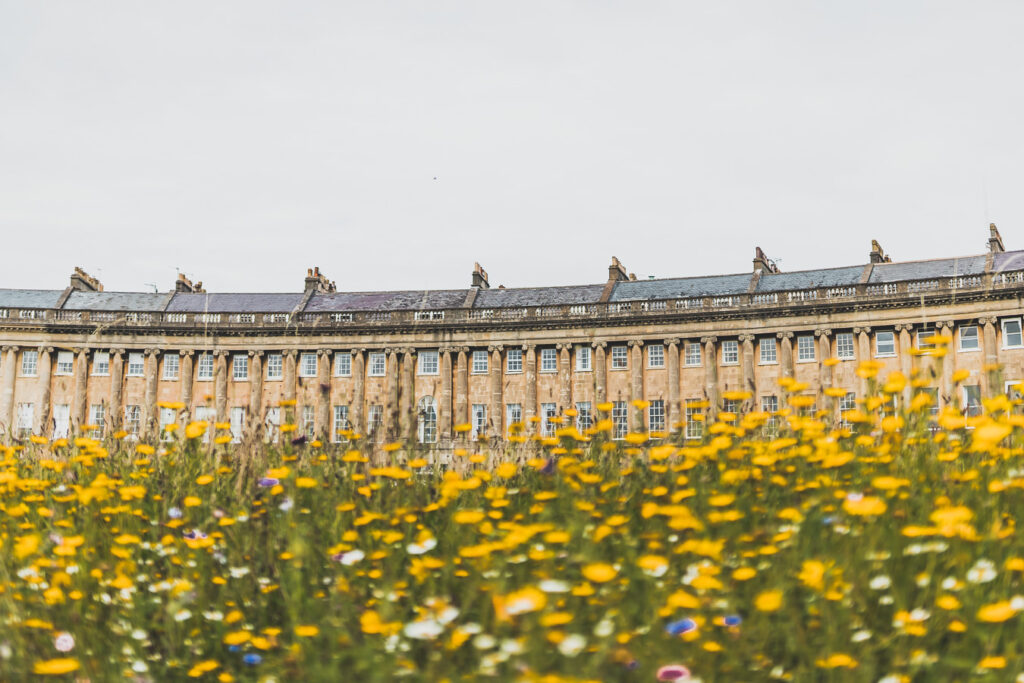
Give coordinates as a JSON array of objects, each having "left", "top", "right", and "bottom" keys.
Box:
[{"left": 0, "top": 0, "right": 1024, "bottom": 291}]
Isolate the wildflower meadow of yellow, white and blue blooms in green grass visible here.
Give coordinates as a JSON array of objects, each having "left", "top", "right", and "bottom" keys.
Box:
[{"left": 0, "top": 350, "right": 1024, "bottom": 683}]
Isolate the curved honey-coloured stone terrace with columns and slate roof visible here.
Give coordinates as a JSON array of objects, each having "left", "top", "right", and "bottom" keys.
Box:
[{"left": 0, "top": 225, "right": 1024, "bottom": 451}]
